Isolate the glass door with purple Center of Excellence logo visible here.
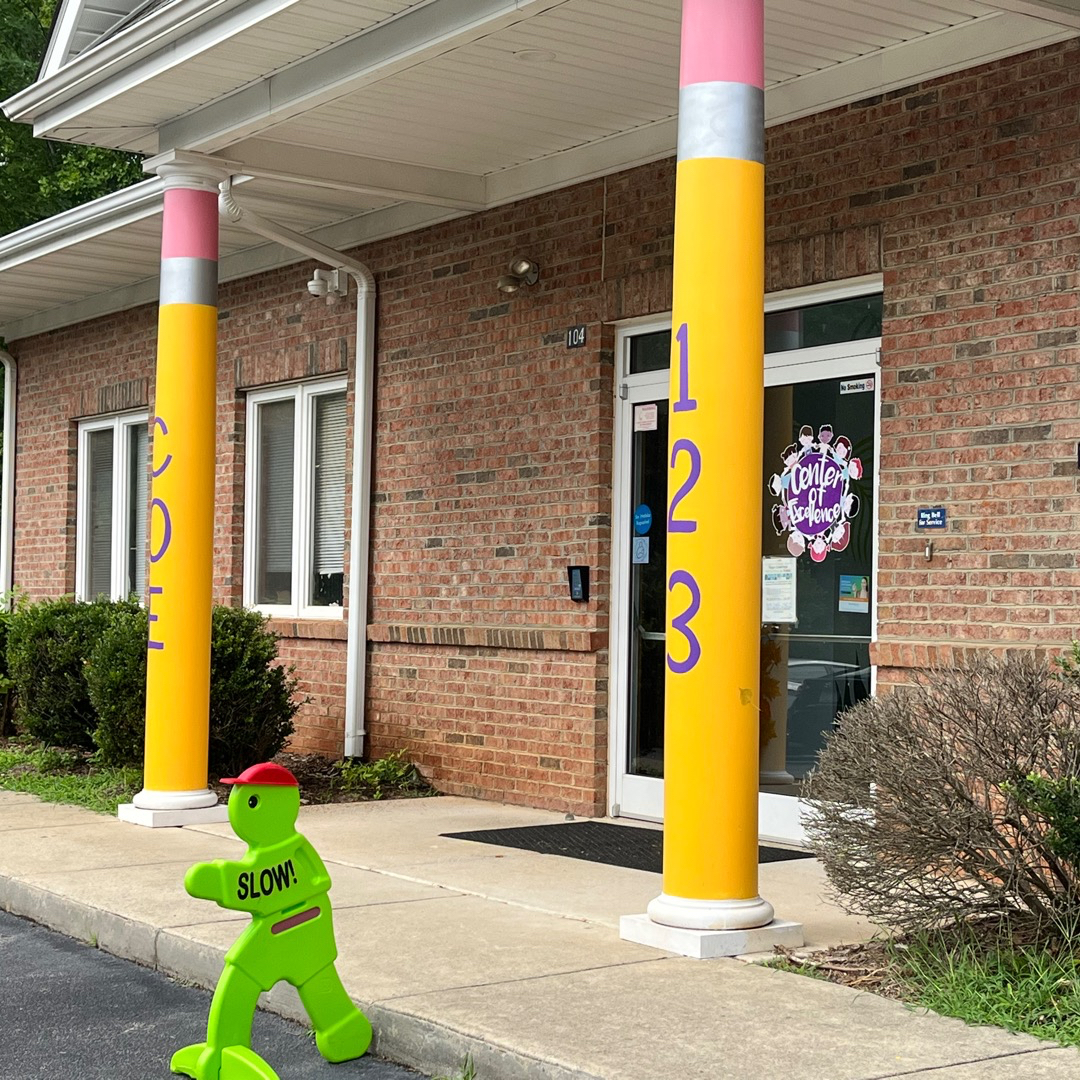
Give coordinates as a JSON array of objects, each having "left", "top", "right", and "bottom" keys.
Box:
[{"left": 759, "top": 353, "right": 877, "bottom": 842}]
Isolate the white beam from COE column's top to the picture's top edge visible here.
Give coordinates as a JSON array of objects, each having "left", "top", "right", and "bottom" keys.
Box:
[{"left": 159, "top": 0, "right": 565, "bottom": 153}]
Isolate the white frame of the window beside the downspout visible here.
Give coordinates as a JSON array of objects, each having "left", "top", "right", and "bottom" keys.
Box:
[{"left": 244, "top": 379, "right": 348, "bottom": 619}]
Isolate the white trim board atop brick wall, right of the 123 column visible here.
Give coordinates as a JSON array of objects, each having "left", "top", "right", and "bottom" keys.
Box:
[{"left": 765, "top": 12, "right": 1078, "bottom": 126}]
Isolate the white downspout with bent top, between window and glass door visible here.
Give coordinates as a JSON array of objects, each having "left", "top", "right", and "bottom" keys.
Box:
[{"left": 218, "top": 181, "right": 376, "bottom": 757}]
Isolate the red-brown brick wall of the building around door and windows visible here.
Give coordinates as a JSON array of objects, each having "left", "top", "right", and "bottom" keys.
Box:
[{"left": 8, "top": 43, "right": 1080, "bottom": 813}]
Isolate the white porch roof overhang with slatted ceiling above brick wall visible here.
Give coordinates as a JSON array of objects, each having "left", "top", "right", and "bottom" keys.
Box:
[{"left": 0, "top": 0, "right": 1080, "bottom": 339}]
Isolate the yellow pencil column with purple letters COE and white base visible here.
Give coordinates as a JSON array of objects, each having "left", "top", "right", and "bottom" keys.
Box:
[{"left": 120, "top": 154, "right": 226, "bottom": 826}]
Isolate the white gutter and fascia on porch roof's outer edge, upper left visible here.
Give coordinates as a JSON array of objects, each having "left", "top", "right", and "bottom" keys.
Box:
[{"left": 0, "top": 0, "right": 298, "bottom": 135}]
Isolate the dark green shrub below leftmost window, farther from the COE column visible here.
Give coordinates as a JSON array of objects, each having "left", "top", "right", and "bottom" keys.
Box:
[{"left": 8, "top": 598, "right": 137, "bottom": 748}]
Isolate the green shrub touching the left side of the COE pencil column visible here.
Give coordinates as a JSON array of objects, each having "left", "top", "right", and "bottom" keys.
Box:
[{"left": 86, "top": 607, "right": 149, "bottom": 765}]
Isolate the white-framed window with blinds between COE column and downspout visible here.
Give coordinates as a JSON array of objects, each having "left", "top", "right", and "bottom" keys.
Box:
[{"left": 244, "top": 380, "right": 346, "bottom": 618}]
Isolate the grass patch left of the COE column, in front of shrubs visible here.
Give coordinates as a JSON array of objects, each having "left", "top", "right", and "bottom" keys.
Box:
[{"left": 0, "top": 740, "right": 143, "bottom": 815}]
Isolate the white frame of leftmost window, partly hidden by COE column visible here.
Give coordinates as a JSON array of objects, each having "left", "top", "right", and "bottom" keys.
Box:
[{"left": 75, "top": 409, "right": 150, "bottom": 604}]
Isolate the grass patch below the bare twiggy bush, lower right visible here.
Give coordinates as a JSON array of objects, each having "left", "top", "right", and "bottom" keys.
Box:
[{"left": 889, "top": 930, "right": 1080, "bottom": 1045}]
